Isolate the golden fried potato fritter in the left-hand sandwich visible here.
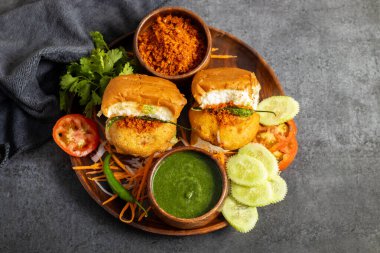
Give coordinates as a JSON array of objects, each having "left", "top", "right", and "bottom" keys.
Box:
[{"left": 109, "top": 118, "right": 176, "bottom": 157}]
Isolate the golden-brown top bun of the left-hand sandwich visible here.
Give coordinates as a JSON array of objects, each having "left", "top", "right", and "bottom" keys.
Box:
[{"left": 102, "top": 74, "right": 186, "bottom": 118}]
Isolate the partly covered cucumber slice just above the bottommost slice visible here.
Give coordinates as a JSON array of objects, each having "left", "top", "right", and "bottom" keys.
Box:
[{"left": 231, "top": 181, "right": 273, "bottom": 207}]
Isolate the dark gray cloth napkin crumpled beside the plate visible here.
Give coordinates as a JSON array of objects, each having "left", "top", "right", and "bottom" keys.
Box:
[{"left": 0, "top": 0, "right": 166, "bottom": 168}]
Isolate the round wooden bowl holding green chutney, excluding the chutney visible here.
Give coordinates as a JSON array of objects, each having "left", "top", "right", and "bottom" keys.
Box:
[{"left": 147, "top": 146, "right": 228, "bottom": 229}]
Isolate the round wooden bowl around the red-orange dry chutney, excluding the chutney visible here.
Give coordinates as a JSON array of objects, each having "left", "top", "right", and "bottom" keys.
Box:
[{"left": 133, "top": 7, "right": 212, "bottom": 81}]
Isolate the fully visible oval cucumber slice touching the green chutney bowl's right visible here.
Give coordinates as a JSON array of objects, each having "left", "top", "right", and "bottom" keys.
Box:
[{"left": 227, "top": 154, "right": 268, "bottom": 186}]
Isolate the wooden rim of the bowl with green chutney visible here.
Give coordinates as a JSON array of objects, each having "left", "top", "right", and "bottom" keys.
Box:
[{"left": 147, "top": 146, "right": 228, "bottom": 224}]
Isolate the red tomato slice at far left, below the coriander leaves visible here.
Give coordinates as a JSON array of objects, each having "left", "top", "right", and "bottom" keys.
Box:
[{"left": 53, "top": 114, "right": 99, "bottom": 157}]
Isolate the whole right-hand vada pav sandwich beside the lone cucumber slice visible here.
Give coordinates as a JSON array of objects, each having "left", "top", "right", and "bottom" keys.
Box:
[{"left": 189, "top": 68, "right": 261, "bottom": 150}]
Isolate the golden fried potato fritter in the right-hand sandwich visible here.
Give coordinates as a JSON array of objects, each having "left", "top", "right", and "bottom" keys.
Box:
[{"left": 189, "top": 110, "right": 260, "bottom": 150}]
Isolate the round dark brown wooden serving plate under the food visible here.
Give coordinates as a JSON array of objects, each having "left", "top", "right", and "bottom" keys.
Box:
[{"left": 71, "top": 27, "right": 284, "bottom": 236}]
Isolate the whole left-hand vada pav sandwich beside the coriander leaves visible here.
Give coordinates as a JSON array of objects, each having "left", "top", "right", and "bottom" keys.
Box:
[{"left": 101, "top": 74, "right": 186, "bottom": 157}]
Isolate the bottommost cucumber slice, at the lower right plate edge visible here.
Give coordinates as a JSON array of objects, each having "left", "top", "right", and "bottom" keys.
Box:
[{"left": 222, "top": 196, "right": 259, "bottom": 233}]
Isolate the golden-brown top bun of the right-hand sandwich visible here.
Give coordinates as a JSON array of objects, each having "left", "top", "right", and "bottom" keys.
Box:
[{"left": 191, "top": 68, "right": 260, "bottom": 104}]
